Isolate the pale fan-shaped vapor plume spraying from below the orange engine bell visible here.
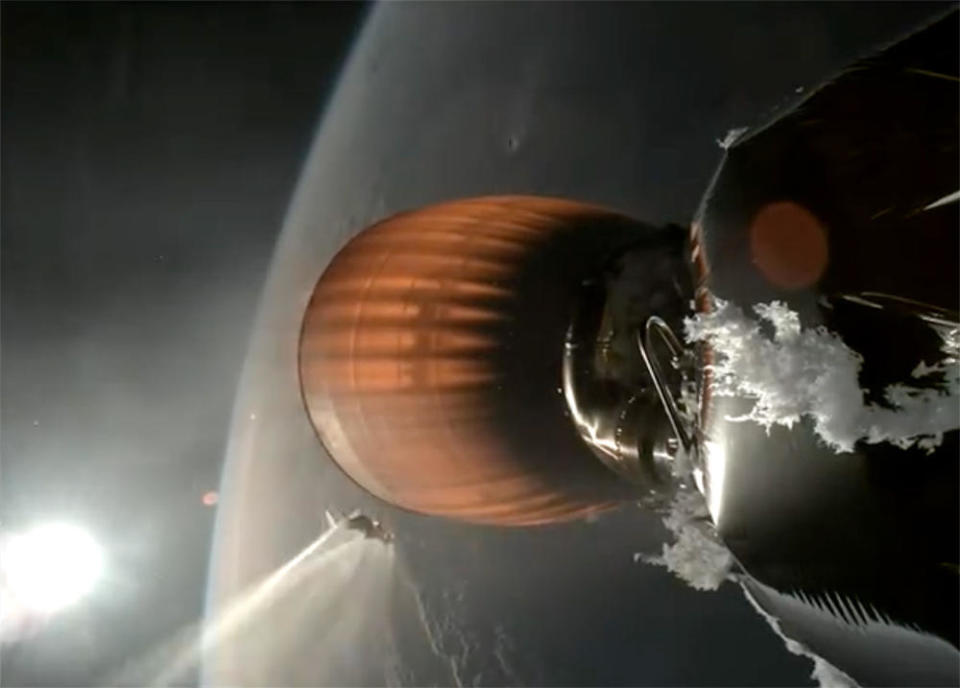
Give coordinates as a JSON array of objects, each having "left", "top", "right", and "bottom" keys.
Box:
[{"left": 113, "top": 522, "right": 409, "bottom": 686}]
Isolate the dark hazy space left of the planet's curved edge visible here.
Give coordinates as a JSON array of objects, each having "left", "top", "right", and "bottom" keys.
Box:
[{"left": 0, "top": 3, "right": 368, "bottom": 685}]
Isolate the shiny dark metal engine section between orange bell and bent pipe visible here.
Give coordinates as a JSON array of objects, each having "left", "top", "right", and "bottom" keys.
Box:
[{"left": 563, "top": 227, "right": 692, "bottom": 494}]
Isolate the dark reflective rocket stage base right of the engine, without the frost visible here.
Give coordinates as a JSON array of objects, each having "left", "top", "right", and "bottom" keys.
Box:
[{"left": 692, "top": 12, "right": 960, "bottom": 685}]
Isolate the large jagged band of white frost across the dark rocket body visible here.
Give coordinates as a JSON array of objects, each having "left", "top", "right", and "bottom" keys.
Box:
[{"left": 684, "top": 298, "right": 960, "bottom": 453}]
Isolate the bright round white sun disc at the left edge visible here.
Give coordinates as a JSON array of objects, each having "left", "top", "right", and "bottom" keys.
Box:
[{"left": 0, "top": 523, "right": 103, "bottom": 613}]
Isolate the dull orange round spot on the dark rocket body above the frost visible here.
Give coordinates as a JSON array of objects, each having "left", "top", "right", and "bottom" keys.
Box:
[{"left": 750, "top": 201, "right": 829, "bottom": 289}]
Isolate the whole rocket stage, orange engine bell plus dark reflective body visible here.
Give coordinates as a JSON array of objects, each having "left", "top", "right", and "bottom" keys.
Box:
[{"left": 300, "top": 12, "right": 960, "bottom": 685}]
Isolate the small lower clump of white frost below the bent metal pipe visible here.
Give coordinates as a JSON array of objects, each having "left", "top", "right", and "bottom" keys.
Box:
[{"left": 638, "top": 490, "right": 733, "bottom": 590}]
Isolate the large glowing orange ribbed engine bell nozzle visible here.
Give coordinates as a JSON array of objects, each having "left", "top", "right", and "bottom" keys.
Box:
[{"left": 300, "top": 196, "right": 684, "bottom": 525}]
